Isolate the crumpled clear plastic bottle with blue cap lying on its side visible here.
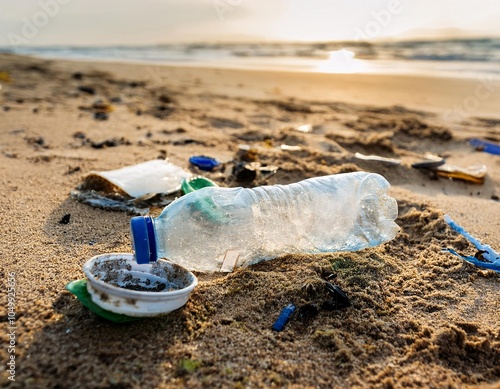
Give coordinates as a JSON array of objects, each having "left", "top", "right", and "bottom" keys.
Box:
[{"left": 130, "top": 172, "right": 399, "bottom": 271}]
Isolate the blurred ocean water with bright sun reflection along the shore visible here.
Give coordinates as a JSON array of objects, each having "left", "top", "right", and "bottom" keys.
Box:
[{"left": 0, "top": 38, "right": 500, "bottom": 78}]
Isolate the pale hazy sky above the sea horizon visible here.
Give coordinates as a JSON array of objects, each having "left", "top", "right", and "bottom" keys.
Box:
[{"left": 0, "top": 0, "right": 500, "bottom": 46}]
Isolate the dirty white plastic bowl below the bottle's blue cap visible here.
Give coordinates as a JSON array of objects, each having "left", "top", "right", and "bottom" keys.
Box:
[{"left": 83, "top": 253, "right": 198, "bottom": 317}]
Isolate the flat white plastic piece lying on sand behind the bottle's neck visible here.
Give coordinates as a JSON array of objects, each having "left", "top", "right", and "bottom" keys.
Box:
[{"left": 90, "top": 159, "right": 191, "bottom": 197}]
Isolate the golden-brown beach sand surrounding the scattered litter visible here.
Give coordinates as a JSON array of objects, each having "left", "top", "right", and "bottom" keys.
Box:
[{"left": 0, "top": 55, "right": 500, "bottom": 388}]
